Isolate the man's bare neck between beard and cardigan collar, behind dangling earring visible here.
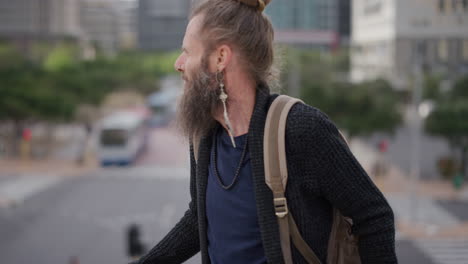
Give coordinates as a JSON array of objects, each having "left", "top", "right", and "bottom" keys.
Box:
[{"left": 215, "top": 80, "right": 256, "bottom": 137}]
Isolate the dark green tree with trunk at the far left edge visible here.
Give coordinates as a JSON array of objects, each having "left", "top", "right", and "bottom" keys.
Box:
[{"left": 0, "top": 50, "right": 73, "bottom": 154}]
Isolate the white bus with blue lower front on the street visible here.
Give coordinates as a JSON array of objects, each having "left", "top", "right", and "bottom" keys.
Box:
[{"left": 97, "top": 111, "right": 148, "bottom": 166}]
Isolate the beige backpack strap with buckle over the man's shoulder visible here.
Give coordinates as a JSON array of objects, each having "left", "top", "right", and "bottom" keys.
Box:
[{"left": 263, "top": 95, "right": 320, "bottom": 264}]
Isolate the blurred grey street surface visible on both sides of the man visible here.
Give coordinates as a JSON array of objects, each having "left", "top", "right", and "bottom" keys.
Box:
[{"left": 0, "top": 128, "right": 468, "bottom": 264}]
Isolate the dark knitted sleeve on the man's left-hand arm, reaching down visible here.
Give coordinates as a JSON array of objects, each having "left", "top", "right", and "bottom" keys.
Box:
[{"left": 137, "top": 147, "right": 200, "bottom": 264}]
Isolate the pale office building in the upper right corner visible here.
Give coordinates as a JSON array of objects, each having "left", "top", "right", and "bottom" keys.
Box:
[{"left": 351, "top": 0, "right": 468, "bottom": 88}]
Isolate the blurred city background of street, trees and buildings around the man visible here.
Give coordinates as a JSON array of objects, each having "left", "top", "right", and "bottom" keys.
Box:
[{"left": 0, "top": 0, "right": 468, "bottom": 264}]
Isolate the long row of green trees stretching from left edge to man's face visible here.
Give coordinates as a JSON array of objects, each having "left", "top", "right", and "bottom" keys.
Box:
[{"left": 0, "top": 42, "right": 179, "bottom": 156}]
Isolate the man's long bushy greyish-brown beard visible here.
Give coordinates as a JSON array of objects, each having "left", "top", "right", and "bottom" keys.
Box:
[{"left": 177, "top": 69, "right": 221, "bottom": 141}]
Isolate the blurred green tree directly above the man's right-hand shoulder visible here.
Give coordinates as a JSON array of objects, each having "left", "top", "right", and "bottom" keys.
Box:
[{"left": 301, "top": 80, "right": 402, "bottom": 137}]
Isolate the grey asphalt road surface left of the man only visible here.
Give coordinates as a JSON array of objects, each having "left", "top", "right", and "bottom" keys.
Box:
[{"left": 0, "top": 168, "right": 199, "bottom": 264}]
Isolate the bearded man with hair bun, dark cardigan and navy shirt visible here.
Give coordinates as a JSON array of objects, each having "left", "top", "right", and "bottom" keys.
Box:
[{"left": 133, "top": 0, "right": 397, "bottom": 264}]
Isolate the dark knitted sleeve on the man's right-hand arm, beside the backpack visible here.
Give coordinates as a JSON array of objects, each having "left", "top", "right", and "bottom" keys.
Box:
[{"left": 289, "top": 104, "right": 397, "bottom": 264}]
